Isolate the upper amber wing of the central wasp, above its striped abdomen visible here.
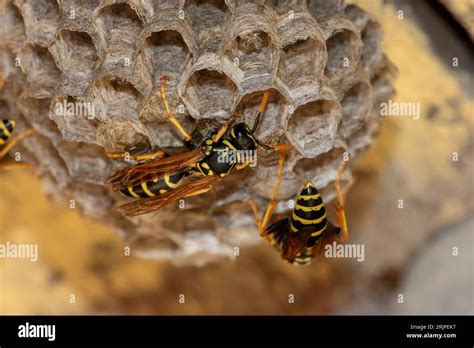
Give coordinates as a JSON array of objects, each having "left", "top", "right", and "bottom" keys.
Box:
[{"left": 105, "top": 148, "right": 206, "bottom": 191}]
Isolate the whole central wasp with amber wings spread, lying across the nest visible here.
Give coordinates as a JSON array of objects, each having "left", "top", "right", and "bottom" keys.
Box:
[{"left": 106, "top": 77, "right": 290, "bottom": 216}]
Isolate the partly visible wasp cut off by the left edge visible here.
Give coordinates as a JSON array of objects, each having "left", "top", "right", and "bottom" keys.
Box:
[{"left": 0, "top": 74, "right": 35, "bottom": 170}]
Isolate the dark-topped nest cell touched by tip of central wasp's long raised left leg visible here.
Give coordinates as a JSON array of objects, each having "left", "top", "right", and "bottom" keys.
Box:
[{"left": 141, "top": 30, "right": 192, "bottom": 84}]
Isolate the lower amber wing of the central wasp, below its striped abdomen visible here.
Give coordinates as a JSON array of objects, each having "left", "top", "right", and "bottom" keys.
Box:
[{"left": 118, "top": 176, "right": 221, "bottom": 216}]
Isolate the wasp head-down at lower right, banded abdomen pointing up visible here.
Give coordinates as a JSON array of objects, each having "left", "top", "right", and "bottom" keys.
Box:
[{"left": 248, "top": 160, "right": 354, "bottom": 266}]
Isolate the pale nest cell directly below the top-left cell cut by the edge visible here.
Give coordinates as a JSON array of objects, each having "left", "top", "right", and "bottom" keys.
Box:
[{"left": 19, "top": 44, "right": 61, "bottom": 98}]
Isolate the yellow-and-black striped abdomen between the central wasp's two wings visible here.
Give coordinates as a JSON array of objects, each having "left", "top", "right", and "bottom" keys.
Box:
[{"left": 120, "top": 172, "right": 185, "bottom": 198}]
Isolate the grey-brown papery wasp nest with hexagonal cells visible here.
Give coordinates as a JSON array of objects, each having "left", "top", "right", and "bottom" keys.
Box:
[{"left": 0, "top": 0, "right": 393, "bottom": 264}]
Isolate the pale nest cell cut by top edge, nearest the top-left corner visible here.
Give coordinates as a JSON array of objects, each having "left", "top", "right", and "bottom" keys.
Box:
[{"left": 16, "top": 0, "right": 61, "bottom": 46}]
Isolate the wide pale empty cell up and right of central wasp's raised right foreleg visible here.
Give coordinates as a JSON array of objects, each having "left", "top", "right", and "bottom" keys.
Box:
[{"left": 278, "top": 37, "right": 325, "bottom": 90}]
